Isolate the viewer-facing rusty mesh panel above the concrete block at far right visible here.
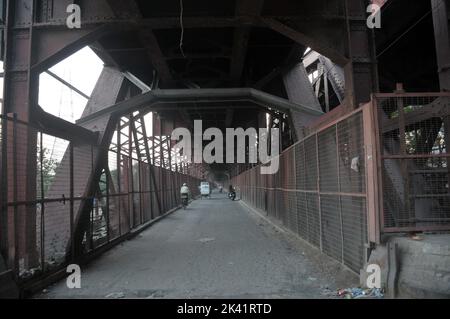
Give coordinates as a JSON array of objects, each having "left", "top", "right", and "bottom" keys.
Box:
[{"left": 375, "top": 93, "right": 450, "bottom": 232}]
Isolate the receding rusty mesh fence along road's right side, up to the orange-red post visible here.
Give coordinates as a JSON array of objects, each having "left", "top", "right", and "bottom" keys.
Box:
[{"left": 233, "top": 107, "right": 375, "bottom": 272}]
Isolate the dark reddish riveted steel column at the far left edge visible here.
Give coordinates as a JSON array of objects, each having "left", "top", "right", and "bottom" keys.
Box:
[{"left": 2, "top": 0, "right": 39, "bottom": 268}]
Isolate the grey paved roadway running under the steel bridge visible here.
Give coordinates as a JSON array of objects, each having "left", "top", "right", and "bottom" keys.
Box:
[{"left": 35, "top": 192, "right": 358, "bottom": 298}]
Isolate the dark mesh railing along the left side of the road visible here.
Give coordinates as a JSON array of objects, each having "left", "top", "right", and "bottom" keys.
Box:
[{"left": 0, "top": 115, "right": 200, "bottom": 285}]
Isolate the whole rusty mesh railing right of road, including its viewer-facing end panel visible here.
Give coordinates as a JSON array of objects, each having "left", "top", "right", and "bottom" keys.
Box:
[{"left": 233, "top": 93, "right": 450, "bottom": 272}]
